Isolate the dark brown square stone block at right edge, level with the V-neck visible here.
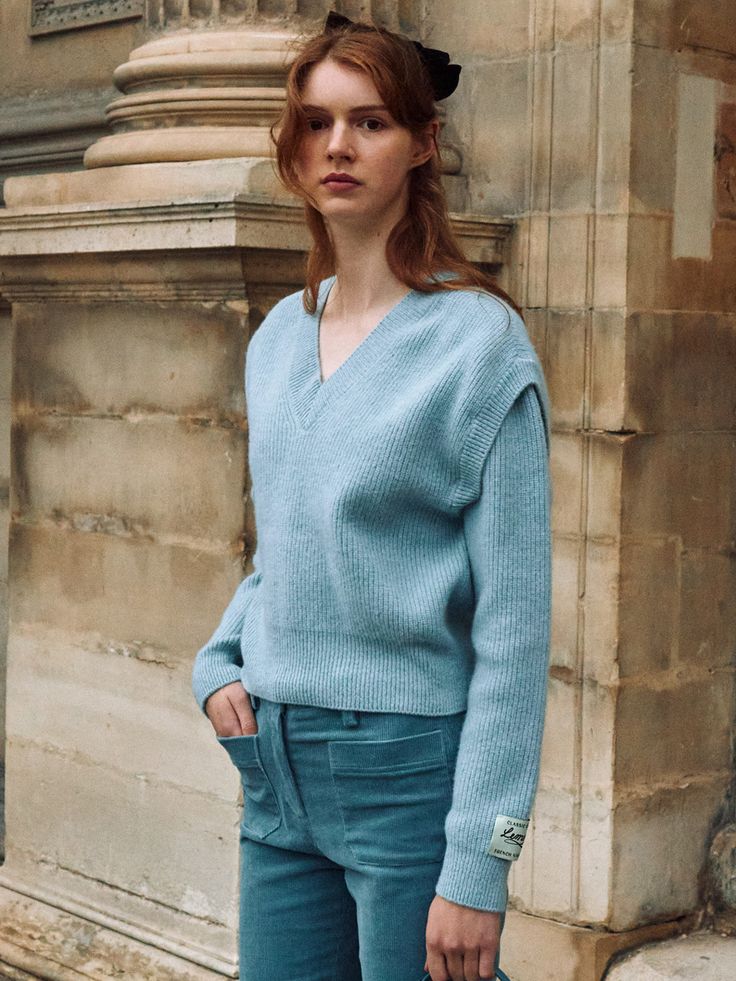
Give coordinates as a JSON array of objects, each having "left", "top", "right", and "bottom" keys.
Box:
[{"left": 626, "top": 312, "right": 736, "bottom": 432}]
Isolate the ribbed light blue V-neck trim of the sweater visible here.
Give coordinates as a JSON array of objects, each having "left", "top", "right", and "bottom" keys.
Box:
[{"left": 289, "top": 276, "right": 426, "bottom": 429}]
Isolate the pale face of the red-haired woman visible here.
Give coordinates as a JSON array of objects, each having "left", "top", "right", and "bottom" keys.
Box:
[{"left": 297, "top": 59, "right": 437, "bottom": 228}]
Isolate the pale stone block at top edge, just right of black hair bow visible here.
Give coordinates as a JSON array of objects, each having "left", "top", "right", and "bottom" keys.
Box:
[{"left": 425, "top": 0, "right": 534, "bottom": 56}]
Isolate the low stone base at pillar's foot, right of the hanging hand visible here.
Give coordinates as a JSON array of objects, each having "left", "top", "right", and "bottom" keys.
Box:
[{"left": 501, "top": 910, "right": 696, "bottom": 981}]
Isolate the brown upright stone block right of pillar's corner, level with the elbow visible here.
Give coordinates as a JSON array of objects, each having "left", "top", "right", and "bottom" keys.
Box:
[{"left": 619, "top": 538, "right": 681, "bottom": 677}]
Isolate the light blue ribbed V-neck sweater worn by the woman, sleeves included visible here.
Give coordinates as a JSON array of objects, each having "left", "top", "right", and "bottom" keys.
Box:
[{"left": 193, "top": 277, "right": 550, "bottom": 910}]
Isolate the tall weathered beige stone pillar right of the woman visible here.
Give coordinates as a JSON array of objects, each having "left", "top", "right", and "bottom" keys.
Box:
[{"left": 427, "top": 0, "right": 736, "bottom": 981}]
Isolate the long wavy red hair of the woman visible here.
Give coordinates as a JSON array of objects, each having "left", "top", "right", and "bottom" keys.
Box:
[{"left": 271, "top": 17, "right": 521, "bottom": 314}]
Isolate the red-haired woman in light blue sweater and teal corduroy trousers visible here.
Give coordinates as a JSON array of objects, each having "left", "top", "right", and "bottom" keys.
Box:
[{"left": 193, "top": 14, "right": 550, "bottom": 981}]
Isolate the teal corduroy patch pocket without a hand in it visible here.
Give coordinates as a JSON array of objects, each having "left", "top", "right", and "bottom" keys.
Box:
[{"left": 328, "top": 729, "right": 452, "bottom": 866}]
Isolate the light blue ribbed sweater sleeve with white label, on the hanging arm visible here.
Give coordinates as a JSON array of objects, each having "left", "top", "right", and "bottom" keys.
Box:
[{"left": 436, "top": 384, "right": 551, "bottom": 911}]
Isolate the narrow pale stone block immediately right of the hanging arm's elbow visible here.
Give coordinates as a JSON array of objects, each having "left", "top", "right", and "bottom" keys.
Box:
[{"left": 550, "top": 535, "right": 581, "bottom": 673}]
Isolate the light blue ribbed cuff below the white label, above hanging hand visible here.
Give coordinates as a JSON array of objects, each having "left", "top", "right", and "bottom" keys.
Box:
[{"left": 435, "top": 844, "right": 511, "bottom": 913}]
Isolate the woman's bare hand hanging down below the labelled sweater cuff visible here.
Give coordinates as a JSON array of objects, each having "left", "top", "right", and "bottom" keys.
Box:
[{"left": 424, "top": 896, "right": 501, "bottom": 981}]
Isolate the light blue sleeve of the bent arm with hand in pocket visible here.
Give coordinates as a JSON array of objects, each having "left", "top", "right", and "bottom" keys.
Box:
[{"left": 192, "top": 570, "right": 261, "bottom": 712}]
